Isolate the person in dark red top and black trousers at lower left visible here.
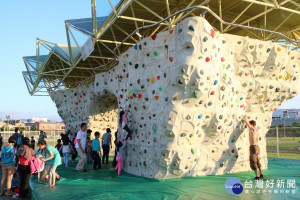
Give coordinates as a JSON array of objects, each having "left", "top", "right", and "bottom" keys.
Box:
[{"left": 17, "top": 137, "right": 35, "bottom": 199}]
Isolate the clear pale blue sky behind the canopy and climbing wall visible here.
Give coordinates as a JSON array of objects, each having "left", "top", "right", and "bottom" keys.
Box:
[{"left": 0, "top": 0, "right": 300, "bottom": 121}]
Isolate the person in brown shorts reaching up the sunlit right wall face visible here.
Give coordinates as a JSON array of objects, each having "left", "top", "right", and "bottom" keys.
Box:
[{"left": 244, "top": 115, "right": 264, "bottom": 180}]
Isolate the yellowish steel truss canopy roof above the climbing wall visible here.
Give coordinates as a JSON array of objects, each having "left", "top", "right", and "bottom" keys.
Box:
[{"left": 23, "top": 0, "right": 300, "bottom": 95}]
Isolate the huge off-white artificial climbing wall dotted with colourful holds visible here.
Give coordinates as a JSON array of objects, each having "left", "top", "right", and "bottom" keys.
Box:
[{"left": 51, "top": 17, "right": 300, "bottom": 179}]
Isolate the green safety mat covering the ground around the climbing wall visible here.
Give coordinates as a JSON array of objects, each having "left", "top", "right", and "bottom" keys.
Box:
[{"left": 30, "top": 158, "right": 300, "bottom": 200}]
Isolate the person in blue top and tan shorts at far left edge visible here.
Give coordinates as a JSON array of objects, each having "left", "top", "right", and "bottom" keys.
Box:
[{"left": 0, "top": 136, "right": 16, "bottom": 196}]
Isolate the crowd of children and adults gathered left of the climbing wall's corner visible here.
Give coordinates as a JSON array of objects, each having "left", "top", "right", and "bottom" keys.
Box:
[{"left": 0, "top": 107, "right": 132, "bottom": 199}]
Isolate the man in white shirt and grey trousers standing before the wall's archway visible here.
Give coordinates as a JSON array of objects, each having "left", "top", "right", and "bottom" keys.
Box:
[{"left": 74, "top": 123, "right": 87, "bottom": 172}]
